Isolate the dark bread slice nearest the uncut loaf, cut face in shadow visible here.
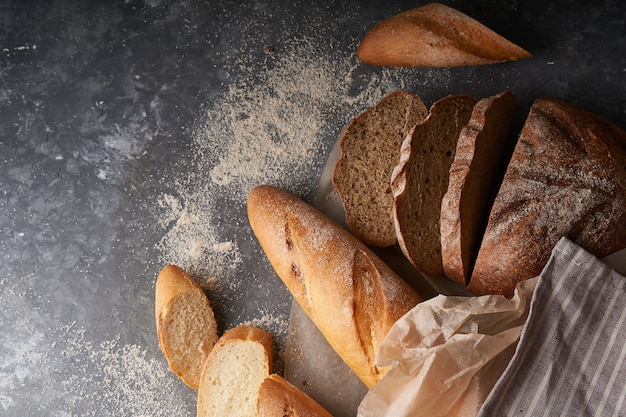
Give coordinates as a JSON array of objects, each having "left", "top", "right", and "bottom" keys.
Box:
[{"left": 440, "top": 91, "right": 515, "bottom": 285}]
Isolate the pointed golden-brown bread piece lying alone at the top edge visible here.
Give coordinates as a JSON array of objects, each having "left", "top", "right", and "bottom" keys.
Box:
[{"left": 357, "top": 3, "right": 531, "bottom": 67}]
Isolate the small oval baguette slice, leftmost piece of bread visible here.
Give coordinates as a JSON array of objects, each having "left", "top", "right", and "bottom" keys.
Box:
[{"left": 155, "top": 265, "right": 217, "bottom": 389}]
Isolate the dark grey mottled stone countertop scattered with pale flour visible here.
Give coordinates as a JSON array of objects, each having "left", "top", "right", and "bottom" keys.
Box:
[{"left": 0, "top": 0, "right": 626, "bottom": 416}]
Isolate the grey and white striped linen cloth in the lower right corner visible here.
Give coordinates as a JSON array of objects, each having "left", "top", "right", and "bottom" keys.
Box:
[{"left": 479, "top": 238, "right": 626, "bottom": 417}]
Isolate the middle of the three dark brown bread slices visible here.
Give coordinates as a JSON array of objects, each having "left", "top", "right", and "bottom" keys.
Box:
[{"left": 391, "top": 95, "right": 476, "bottom": 276}]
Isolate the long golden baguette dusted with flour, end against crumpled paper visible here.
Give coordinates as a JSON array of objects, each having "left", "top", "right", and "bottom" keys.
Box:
[{"left": 248, "top": 185, "right": 422, "bottom": 387}]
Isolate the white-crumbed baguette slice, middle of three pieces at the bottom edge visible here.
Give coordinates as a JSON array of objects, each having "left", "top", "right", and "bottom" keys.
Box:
[{"left": 197, "top": 326, "right": 272, "bottom": 417}]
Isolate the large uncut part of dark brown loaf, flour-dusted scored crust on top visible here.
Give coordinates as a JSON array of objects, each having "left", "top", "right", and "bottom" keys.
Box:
[{"left": 469, "top": 99, "right": 626, "bottom": 296}]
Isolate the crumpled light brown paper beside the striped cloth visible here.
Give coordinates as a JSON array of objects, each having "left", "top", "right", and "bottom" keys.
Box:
[{"left": 358, "top": 278, "right": 538, "bottom": 417}]
